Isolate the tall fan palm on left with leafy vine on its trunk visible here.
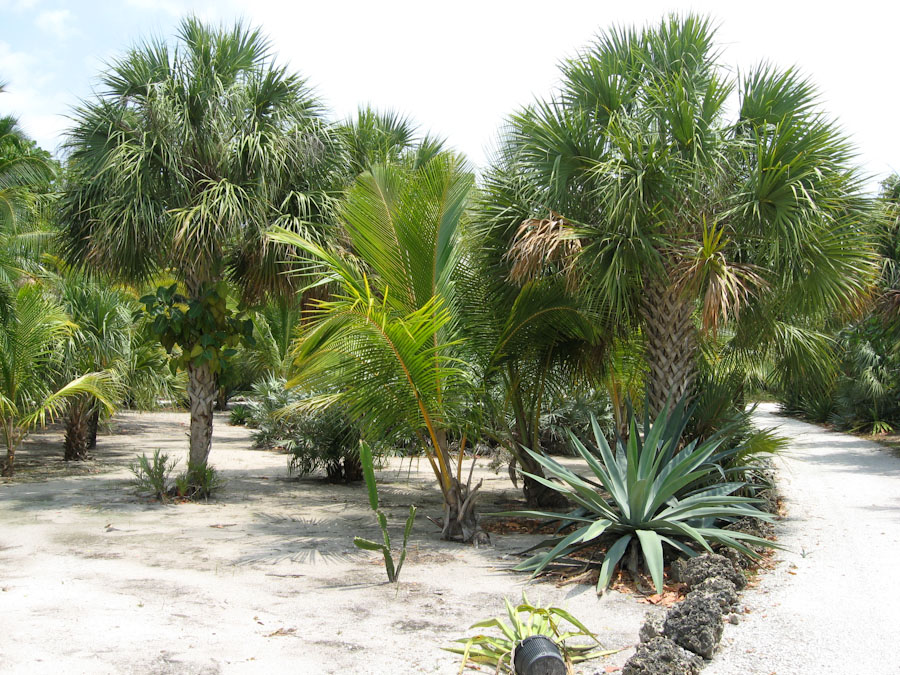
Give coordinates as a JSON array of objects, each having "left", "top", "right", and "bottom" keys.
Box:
[{"left": 62, "top": 17, "right": 342, "bottom": 466}]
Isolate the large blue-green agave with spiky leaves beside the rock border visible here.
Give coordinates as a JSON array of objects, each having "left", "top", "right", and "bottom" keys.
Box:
[{"left": 506, "top": 402, "right": 773, "bottom": 593}]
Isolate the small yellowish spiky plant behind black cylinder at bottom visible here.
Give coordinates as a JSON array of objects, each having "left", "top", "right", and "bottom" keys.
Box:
[{"left": 444, "top": 593, "right": 614, "bottom": 673}]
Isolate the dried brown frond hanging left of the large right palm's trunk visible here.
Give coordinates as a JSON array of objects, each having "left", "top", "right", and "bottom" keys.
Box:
[{"left": 504, "top": 211, "right": 581, "bottom": 290}]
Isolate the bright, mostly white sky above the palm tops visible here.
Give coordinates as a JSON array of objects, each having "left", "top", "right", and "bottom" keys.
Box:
[{"left": 0, "top": 0, "right": 900, "bottom": 190}]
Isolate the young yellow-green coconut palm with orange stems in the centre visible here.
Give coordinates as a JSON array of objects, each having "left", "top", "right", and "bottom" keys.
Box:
[{"left": 271, "top": 154, "right": 480, "bottom": 541}]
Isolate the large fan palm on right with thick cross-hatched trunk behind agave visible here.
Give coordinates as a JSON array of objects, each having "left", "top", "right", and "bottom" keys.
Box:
[{"left": 493, "top": 15, "right": 871, "bottom": 414}]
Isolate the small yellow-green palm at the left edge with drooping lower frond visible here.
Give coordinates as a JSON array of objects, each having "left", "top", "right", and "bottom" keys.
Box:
[{"left": 0, "top": 284, "right": 114, "bottom": 476}]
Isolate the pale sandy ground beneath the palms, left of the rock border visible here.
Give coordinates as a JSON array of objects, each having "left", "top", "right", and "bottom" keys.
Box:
[{"left": 0, "top": 413, "right": 652, "bottom": 673}]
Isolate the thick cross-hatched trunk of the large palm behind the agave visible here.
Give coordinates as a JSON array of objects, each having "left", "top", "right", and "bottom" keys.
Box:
[{"left": 641, "top": 279, "right": 697, "bottom": 416}]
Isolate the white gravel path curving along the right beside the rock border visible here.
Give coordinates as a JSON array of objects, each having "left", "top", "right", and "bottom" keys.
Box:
[{"left": 703, "top": 405, "right": 900, "bottom": 675}]
